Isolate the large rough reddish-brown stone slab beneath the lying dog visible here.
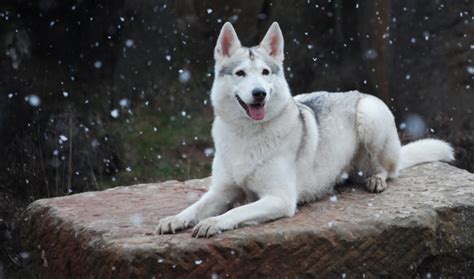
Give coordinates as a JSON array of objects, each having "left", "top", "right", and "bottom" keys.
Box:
[{"left": 22, "top": 163, "right": 474, "bottom": 278}]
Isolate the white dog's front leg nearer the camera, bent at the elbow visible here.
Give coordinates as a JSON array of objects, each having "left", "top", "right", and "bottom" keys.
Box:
[{"left": 193, "top": 160, "right": 297, "bottom": 237}]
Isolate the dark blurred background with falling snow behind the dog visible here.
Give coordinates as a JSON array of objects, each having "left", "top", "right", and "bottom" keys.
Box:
[{"left": 0, "top": 0, "right": 474, "bottom": 278}]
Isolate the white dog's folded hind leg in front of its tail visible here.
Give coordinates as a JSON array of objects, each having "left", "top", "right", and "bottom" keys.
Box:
[{"left": 356, "top": 96, "right": 401, "bottom": 193}]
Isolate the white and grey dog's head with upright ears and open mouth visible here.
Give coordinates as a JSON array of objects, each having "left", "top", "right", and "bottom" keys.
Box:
[{"left": 211, "top": 22, "right": 291, "bottom": 122}]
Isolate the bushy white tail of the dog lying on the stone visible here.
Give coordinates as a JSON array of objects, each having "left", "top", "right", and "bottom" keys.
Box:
[{"left": 400, "top": 139, "right": 454, "bottom": 169}]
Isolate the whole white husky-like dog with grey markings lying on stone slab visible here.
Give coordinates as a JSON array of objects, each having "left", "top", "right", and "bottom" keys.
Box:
[{"left": 157, "top": 22, "right": 454, "bottom": 237}]
